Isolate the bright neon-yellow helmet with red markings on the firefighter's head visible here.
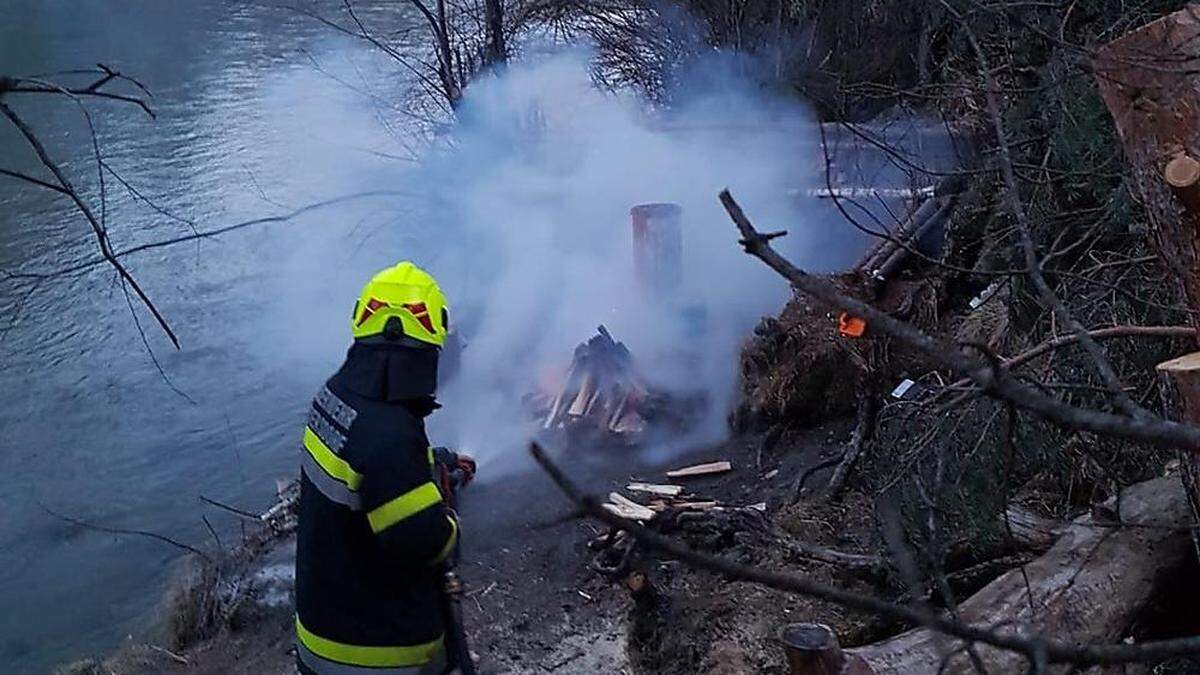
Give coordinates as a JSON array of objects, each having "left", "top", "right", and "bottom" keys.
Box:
[{"left": 350, "top": 261, "right": 449, "bottom": 347}]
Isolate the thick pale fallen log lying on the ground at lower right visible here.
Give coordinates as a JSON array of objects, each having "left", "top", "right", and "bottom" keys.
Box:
[{"left": 848, "top": 476, "right": 1190, "bottom": 675}]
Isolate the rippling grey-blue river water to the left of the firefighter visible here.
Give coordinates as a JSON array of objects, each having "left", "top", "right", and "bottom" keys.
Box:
[{"left": 0, "top": 0, "right": 427, "bottom": 673}]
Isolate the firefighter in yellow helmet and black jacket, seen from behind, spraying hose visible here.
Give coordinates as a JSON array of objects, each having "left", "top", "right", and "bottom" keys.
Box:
[{"left": 295, "top": 262, "right": 475, "bottom": 675}]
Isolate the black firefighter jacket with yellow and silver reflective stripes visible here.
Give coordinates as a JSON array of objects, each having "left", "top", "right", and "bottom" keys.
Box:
[{"left": 295, "top": 351, "right": 458, "bottom": 675}]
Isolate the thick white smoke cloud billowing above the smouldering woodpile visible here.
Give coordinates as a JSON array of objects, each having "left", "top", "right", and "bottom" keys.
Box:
[{"left": 403, "top": 52, "right": 828, "bottom": 468}]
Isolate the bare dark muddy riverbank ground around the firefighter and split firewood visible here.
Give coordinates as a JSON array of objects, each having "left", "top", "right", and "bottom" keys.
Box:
[{"left": 63, "top": 423, "right": 902, "bottom": 674}]
